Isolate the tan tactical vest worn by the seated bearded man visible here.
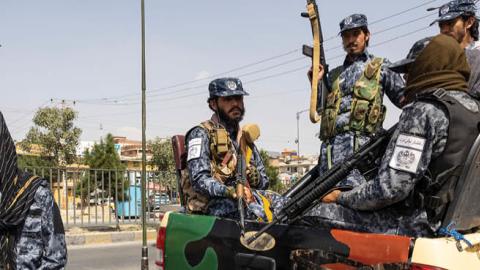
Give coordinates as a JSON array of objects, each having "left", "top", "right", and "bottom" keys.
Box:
[{"left": 181, "top": 120, "right": 237, "bottom": 214}]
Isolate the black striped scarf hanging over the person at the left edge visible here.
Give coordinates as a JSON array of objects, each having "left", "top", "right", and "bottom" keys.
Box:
[{"left": 0, "top": 112, "right": 45, "bottom": 269}]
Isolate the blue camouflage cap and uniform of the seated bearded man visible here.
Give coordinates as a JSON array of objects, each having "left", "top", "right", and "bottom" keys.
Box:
[{"left": 185, "top": 78, "right": 282, "bottom": 220}]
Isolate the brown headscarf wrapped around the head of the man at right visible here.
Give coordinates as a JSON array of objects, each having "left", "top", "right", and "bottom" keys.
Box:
[{"left": 405, "top": 34, "right": 470, "bottom": 101}]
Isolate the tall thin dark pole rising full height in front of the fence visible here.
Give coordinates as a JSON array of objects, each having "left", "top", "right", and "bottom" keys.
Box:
[{"left": 140, "top": 0, "right": 148, "bottom": 270}]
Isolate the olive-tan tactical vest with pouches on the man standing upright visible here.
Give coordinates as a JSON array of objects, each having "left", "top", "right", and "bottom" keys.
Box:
[{"left": 320, "top": 57, "right": 386, "bottom": 141}]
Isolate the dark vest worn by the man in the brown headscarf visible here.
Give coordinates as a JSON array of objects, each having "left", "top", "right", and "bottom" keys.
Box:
[{"left": 414, "top": 89, "right": 480, "bottom": 223}]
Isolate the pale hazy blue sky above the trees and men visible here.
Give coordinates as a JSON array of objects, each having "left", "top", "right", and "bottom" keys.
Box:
[{"left": 0, "top": 0, "right": 446, "bottom": 154}]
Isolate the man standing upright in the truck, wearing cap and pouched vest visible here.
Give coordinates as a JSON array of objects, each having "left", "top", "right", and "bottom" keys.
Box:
[{"left": 312, "top": 14, "right": 404, "bottom": 189}]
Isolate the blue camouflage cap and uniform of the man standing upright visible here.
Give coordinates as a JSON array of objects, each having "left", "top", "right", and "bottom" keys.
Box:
[{"left": 319, "top": 14, "right": 404, "bottom": 186}]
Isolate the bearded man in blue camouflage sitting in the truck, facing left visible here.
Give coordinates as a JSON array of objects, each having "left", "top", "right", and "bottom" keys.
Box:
[{"left": 182, "top": 78, "right": 284, "bottom": 218}]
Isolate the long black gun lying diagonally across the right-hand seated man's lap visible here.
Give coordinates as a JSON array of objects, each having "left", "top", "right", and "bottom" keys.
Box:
[{"left": 246, "top": 125, "right": 397, "bottom": 244}]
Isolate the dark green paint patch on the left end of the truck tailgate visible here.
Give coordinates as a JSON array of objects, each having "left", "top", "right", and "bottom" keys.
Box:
[{"left": 165, "top": 213, "right": 218, "bottom": 270}]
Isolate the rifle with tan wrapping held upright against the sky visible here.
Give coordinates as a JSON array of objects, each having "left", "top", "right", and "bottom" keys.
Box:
[{"left": 301, "top": 0, "right": 331, "bottom": 123}]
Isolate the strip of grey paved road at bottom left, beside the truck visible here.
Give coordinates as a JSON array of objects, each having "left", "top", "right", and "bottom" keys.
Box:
[{"left": 67, "top": 242, "right": 156, "bottom": 270}]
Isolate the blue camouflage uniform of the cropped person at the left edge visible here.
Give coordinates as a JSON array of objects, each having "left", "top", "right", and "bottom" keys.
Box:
[{"left": 16, "top": 181, "right": 67, "bottom": 270}]
